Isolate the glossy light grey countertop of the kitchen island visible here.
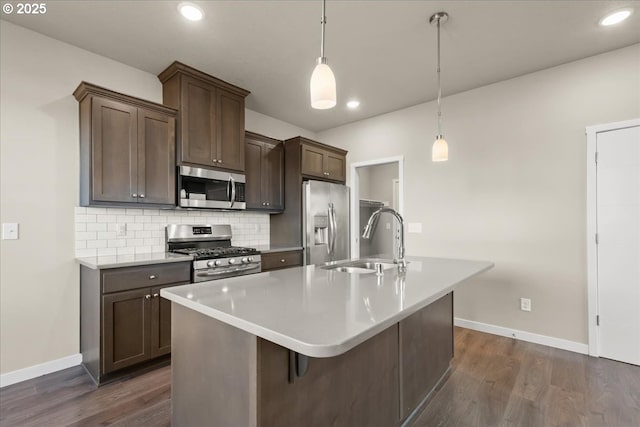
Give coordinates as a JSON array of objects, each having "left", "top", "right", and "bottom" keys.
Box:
[{"left": 160, "top": 257, "right": 493, "bottom": 357}]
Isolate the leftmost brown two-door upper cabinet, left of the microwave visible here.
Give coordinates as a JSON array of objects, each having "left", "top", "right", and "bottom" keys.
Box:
[{"left": 73, "top": 82, "right": 177, "bottom": 207}]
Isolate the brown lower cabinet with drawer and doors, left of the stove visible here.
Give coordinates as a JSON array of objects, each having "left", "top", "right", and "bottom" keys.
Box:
[{"left": 80, "top": 262, "right": 191, "bottom": 384}]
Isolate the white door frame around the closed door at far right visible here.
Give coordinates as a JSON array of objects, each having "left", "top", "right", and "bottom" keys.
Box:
[{"left": 585, "top": 119, "right": 640, "bottom": 357}]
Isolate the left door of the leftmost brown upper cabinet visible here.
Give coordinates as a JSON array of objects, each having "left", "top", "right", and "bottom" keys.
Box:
[{"left": 91, "top": 98, "right": 138, "bottom": 202}]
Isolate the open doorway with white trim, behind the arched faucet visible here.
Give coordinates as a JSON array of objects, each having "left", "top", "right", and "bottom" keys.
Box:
[{"left": 349, "top": 156, "right": 404, "bottom": 258}]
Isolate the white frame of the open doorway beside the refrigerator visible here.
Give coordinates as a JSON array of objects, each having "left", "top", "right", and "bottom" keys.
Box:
[{"left": 349, "top": 156, "right": 404, "bottom": 259}]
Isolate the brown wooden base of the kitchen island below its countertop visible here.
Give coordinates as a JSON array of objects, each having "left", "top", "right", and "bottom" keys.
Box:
[{"left": 171, "top": 293, "right": 453, "bottom": 427}]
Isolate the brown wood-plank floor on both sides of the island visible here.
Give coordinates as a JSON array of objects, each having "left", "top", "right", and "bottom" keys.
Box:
[{"left": 0, "top": 328, "right": 640, "bottom": 427}]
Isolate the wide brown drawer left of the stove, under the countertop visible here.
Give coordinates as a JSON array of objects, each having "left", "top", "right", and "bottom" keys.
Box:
[{"left": 102, "top": 262, "right": 191, "bottom": 293}]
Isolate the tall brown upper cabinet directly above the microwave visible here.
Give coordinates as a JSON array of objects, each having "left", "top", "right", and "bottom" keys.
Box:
[{"left": 158, "top": 61, "right": 250, "bottom": 172}]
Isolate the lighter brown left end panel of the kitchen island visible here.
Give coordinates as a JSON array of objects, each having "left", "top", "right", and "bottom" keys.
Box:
[{"left": 171, "top": 303, "right": 257, "bottom": 427}]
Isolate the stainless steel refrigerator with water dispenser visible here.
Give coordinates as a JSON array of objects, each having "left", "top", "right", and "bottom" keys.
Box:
[{"left": 302, "top": 181, "right": 349, "bottom": 265}]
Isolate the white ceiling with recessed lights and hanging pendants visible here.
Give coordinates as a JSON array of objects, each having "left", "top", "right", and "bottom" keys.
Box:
[{"left": 2, "top": 0, "right": 640, "bottom": 131}]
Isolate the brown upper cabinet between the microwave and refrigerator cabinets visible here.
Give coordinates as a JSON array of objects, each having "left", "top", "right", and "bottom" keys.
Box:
[{"left": 245, "top": 131, "right": 284, "bottom": 212}]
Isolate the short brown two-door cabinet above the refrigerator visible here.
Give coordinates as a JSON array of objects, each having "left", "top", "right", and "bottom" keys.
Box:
[{"left": 298, "top": 137, "right": 347, "bottom": 183}]
